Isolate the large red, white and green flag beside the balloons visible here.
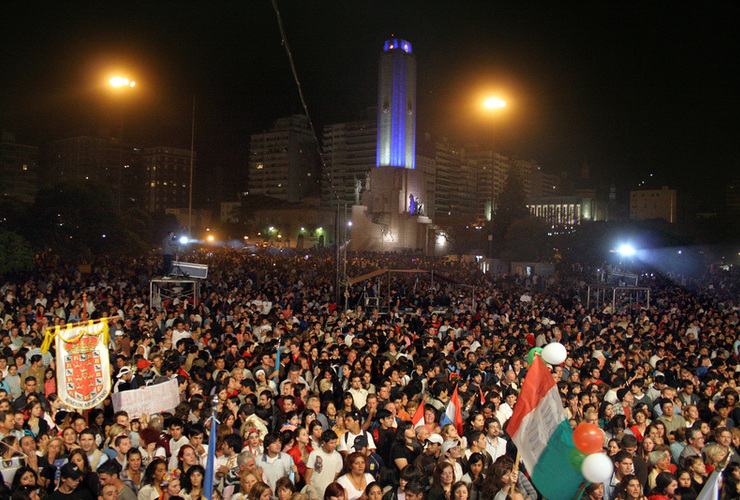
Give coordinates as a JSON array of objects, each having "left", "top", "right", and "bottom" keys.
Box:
[{"left": 507, "top": 356, "right": 584, "bottom": 500}]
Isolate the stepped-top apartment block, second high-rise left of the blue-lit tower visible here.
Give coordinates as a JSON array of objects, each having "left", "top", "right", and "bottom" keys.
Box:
[{"left": 247, "top": 115, "right": 320, "bottom": 203}]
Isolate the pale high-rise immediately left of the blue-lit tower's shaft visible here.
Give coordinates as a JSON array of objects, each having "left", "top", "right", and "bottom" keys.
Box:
[{"left": 321, "top": 120, "right": 378, "bottom": 205}]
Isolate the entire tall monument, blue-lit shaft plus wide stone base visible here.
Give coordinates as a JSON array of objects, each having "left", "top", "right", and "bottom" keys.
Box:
[{"left": 350, "top": 38, "right": 435, "bottom": 254}]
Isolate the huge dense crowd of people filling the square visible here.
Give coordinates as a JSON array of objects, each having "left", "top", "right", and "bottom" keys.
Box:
[{"left": 0, "top": 249, "right": 740, "bottom": 500}]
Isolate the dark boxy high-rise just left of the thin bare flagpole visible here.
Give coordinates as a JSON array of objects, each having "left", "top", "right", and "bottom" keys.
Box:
[{"left": 143, "top": 146, "right": 195, "bottom": 212}]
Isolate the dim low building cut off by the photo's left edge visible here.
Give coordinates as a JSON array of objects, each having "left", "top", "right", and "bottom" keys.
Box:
[{"left": 0, "top": 132, "right": 39, "bottom": 203}]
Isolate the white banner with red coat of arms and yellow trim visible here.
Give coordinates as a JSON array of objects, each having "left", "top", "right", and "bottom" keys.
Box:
[{"left": 42, "top": 318, "right": 111, "bottom": 410}]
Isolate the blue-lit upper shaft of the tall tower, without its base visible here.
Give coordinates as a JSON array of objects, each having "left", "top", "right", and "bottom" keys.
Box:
[{"left": 377, "top": 38, "right": 416, "bottom": 169}]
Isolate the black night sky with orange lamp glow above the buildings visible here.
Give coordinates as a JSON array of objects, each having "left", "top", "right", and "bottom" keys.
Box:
[{"left": 0, "top": 0, "right": 740, "bottom": 208}]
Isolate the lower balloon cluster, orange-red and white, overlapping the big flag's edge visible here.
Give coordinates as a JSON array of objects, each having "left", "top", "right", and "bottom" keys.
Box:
[{"left": 568, "top": 422, "right": 614, "bottom": 483}]
